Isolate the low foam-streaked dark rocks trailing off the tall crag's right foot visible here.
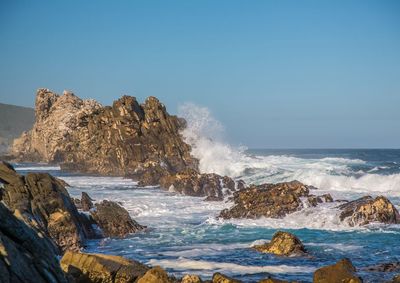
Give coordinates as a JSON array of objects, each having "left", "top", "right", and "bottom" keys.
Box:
[{"left": 160, "top": 169, "right": 244, "bottom": 200}]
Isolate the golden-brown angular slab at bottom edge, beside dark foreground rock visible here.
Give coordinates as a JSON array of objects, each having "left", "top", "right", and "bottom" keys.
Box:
[{"left": 61, "top": 251, "right": 149, "bottom": 283}]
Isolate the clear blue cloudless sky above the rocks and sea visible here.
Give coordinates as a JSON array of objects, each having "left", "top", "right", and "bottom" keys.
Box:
[{"left": 0, "top": 0, "right": 400, "bottom": 148}]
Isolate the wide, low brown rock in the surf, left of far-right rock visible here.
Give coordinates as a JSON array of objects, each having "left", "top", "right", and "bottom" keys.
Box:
[{"left": 220, "top": 181, "right": 330, "bottom": 219}]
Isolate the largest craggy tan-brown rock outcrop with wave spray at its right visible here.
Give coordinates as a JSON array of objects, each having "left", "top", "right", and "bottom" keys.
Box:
[{"left": 13, "top": 89, "right": 198, "bottom": 185}]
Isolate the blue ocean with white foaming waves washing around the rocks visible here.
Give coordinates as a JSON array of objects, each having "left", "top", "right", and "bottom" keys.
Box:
[{"left": 15, "top": 150, "right": 400, "bottom": 282}]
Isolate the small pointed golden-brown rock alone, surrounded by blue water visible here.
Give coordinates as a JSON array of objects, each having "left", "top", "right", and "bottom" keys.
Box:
[{"left": 254, "top": 231, "right": 307, "bottom": 256}]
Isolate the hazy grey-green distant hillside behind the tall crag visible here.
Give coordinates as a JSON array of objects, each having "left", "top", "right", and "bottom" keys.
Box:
[{"left": 0, "top": 103, "right": 35, "bottom": 153}]
